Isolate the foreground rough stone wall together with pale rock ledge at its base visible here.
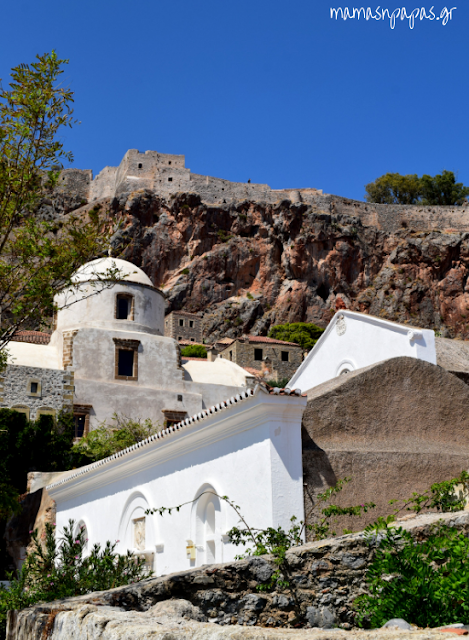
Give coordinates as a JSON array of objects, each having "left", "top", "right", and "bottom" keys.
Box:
[{"left": 7, "top": 512, "right": 469, "bottom": 640}]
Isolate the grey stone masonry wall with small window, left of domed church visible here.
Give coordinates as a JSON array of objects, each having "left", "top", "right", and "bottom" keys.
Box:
[{"left": 0, "top": 365, "right": 74, "bottom": 420}]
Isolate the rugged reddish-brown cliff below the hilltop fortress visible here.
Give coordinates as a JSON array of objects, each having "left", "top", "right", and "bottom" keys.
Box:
[{"left": 55, "top": 191, "right": 469, "bottom": 341}]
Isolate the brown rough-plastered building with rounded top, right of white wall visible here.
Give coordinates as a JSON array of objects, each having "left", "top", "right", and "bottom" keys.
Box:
[{"left": 302, "top": 357, "right": 469, "bottom": 533}]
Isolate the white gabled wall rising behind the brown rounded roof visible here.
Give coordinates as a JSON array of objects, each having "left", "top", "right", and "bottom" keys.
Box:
[{"left": 288, "top": 310, "right": 436, "bottom": 392}]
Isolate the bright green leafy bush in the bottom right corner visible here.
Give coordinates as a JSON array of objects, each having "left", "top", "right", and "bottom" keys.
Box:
[{"left": 356, "top": 522, "right": 469, "bottom": 627}]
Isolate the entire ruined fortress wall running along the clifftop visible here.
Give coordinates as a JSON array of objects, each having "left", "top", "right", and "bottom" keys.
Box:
[{"left": 58, "top": 149, "right": 469, "bottom": 233}]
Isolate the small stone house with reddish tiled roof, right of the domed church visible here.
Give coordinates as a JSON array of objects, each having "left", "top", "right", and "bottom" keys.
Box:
[{"left": 219, "top": 335, "right": 303, "bottom": 381}]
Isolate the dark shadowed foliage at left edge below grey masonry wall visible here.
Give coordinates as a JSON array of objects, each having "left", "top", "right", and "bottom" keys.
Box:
[{"left": 0, "top": 409, "right": 74, "bottom": 518}]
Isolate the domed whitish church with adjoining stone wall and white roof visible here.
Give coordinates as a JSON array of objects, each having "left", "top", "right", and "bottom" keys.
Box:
[{"left": 0, "top": 258, "right": 252, "bottom": 437}]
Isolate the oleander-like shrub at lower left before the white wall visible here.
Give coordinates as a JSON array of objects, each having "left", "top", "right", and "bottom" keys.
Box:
[{"left": 0, "top": 520, "right": 151, "bottom": 632}]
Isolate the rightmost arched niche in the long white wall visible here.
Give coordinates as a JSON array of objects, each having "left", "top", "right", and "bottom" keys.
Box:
[{"left": 191, "top": 484, "right": 223, "bottom": 566}]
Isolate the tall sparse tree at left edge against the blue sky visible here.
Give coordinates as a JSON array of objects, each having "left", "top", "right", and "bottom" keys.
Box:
[{"left": 0, "top": 52, "right": 119, "bottom": 348}]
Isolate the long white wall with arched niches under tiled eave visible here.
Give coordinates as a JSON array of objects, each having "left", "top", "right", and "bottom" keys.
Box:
[{"left": 48, "top": 389, "right": 306, "bottom": 575}]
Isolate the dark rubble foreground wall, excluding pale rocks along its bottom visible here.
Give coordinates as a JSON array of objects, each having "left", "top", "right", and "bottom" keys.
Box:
[{"left": 7, "top": 512, "right": 469, "bottom": 640}]
